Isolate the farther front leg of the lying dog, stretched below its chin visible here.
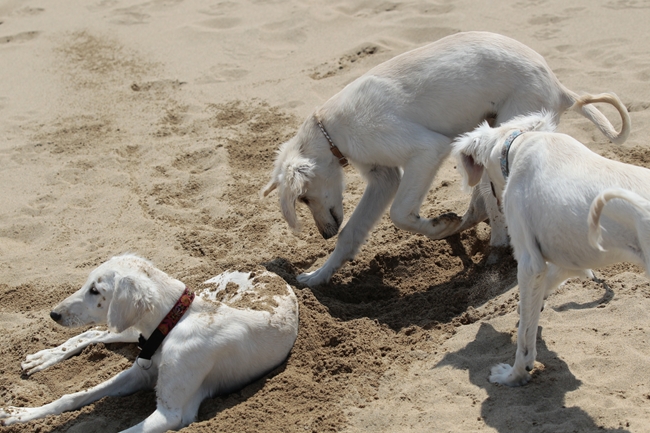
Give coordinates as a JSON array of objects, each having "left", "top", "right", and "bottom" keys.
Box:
[{"left": 20, "top": 328, "right": 138, "bottom": 375}]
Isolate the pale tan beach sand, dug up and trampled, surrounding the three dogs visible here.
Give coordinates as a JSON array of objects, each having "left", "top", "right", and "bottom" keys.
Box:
[{"left": 0, "top": 0, "right": 650, "bottom": 432}]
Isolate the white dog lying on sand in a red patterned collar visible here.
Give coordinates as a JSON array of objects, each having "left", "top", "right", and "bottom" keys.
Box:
[{"left": 0, "top": 255, "right": 298, "bottom": 432}]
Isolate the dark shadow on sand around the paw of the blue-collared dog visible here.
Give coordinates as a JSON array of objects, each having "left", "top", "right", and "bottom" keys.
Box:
[{"left": 433, "top": 323, "right": 629, "bottom": 433}]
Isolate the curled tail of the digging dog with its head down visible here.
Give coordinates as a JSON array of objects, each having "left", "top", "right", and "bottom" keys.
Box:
[{"left": 570, "top": 92, "right": 631, "bottom": 144}]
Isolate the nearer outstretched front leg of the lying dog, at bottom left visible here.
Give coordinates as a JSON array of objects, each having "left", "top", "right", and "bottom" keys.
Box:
[{"left": 0, "top": 364, "right": 156, "bottom": 425}]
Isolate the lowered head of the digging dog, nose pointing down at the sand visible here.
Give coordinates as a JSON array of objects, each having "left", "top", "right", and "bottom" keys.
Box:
[{"left": 262, "top": 125, "right": 344, "bottom": 239}]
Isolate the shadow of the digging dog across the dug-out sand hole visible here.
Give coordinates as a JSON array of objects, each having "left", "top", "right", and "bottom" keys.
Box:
[{"left": 262, "top": 231, "right": 614, "bottom": 332}]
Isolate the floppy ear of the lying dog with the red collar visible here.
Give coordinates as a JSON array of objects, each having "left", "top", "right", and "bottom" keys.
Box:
[{"left": 106, "top": 277, "right": 147, "bottom": 332}]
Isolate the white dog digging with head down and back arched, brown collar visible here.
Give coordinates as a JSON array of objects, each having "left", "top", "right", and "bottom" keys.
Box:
[{"left": 262, "top": 32, "right": 629, "bottom": 286}]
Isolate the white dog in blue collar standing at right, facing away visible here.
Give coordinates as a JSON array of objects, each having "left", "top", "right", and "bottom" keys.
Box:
[{"left": 453, "top": 99, "right": 636, "bottom": 386}]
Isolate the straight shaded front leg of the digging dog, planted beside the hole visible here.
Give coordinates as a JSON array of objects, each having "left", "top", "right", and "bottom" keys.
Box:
[{"left": 297, "top": 167, "right": 401, "bottom": 287}]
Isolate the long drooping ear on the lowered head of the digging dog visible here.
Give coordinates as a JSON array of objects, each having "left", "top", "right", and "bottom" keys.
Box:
[{"left": 280, "top": 157, "right": 314, "bottom": 230}]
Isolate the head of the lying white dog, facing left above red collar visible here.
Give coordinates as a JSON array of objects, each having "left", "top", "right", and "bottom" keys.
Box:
[{"left": 50, "top": 254, "right": 161, "bottom": 332}]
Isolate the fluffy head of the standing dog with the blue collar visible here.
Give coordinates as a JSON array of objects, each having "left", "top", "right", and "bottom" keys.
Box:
[{"left": 452, "top": 111, "right": 556, "bottom": 200}]
